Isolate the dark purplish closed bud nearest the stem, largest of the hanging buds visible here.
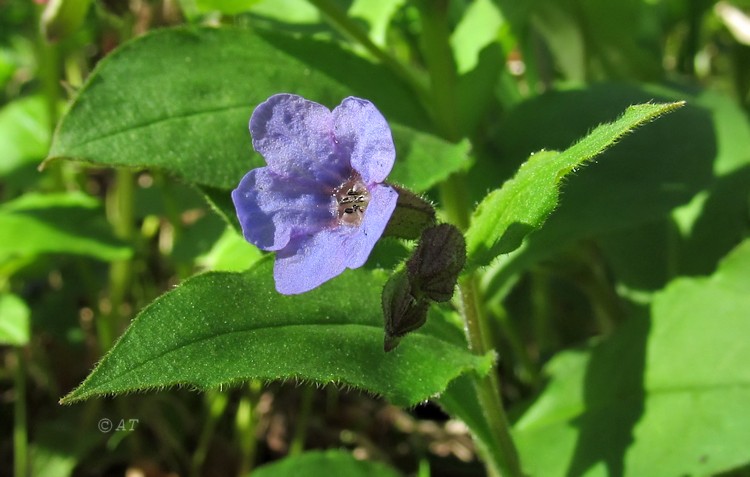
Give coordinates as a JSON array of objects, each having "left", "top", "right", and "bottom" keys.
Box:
[{"left": 406, "top": 224, "right": 466, "bottom": 302}]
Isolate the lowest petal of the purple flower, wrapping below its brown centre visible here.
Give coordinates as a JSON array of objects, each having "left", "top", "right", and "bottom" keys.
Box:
[{"left": 273, "top": 185, "right": 398, "bottom": 295}]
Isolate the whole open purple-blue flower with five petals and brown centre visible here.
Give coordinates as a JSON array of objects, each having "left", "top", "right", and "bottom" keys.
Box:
[{"left": 232, "top": 94, "right": 398, "bottom": 295}]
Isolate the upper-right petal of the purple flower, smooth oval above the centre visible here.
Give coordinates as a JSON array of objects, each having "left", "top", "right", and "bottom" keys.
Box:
[{"left": 333, "top": 97, "right": 396, "bottom": 184}]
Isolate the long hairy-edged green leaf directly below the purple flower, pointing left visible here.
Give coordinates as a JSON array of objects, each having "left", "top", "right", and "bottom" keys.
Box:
[{"left": 63, "top": 260, "right": 492, "bottom": 406}]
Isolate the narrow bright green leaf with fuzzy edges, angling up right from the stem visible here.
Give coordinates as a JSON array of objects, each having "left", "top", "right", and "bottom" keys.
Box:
[{"left": 466, "top": 102, "right": 684, "bottom": 267}]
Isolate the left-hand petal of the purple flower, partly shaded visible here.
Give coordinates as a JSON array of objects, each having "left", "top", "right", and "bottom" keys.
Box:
[{"left": 232, "top": 167, "right": 336, "bottom": 250}]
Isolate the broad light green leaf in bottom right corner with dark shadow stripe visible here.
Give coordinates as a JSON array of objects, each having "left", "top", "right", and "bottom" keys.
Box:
[{"left": 515, "top": 241, "right": 750, "bottom": 477}]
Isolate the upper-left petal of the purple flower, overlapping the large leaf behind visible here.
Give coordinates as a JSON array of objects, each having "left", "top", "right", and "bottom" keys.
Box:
[{"left": 250, "top": 94, "right": 350, "bottom": 187}]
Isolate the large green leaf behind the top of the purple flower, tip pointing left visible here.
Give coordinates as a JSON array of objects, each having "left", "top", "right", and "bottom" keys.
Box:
[{"left": 49, "top": 28, "right": 467, "bottom": 190}]
